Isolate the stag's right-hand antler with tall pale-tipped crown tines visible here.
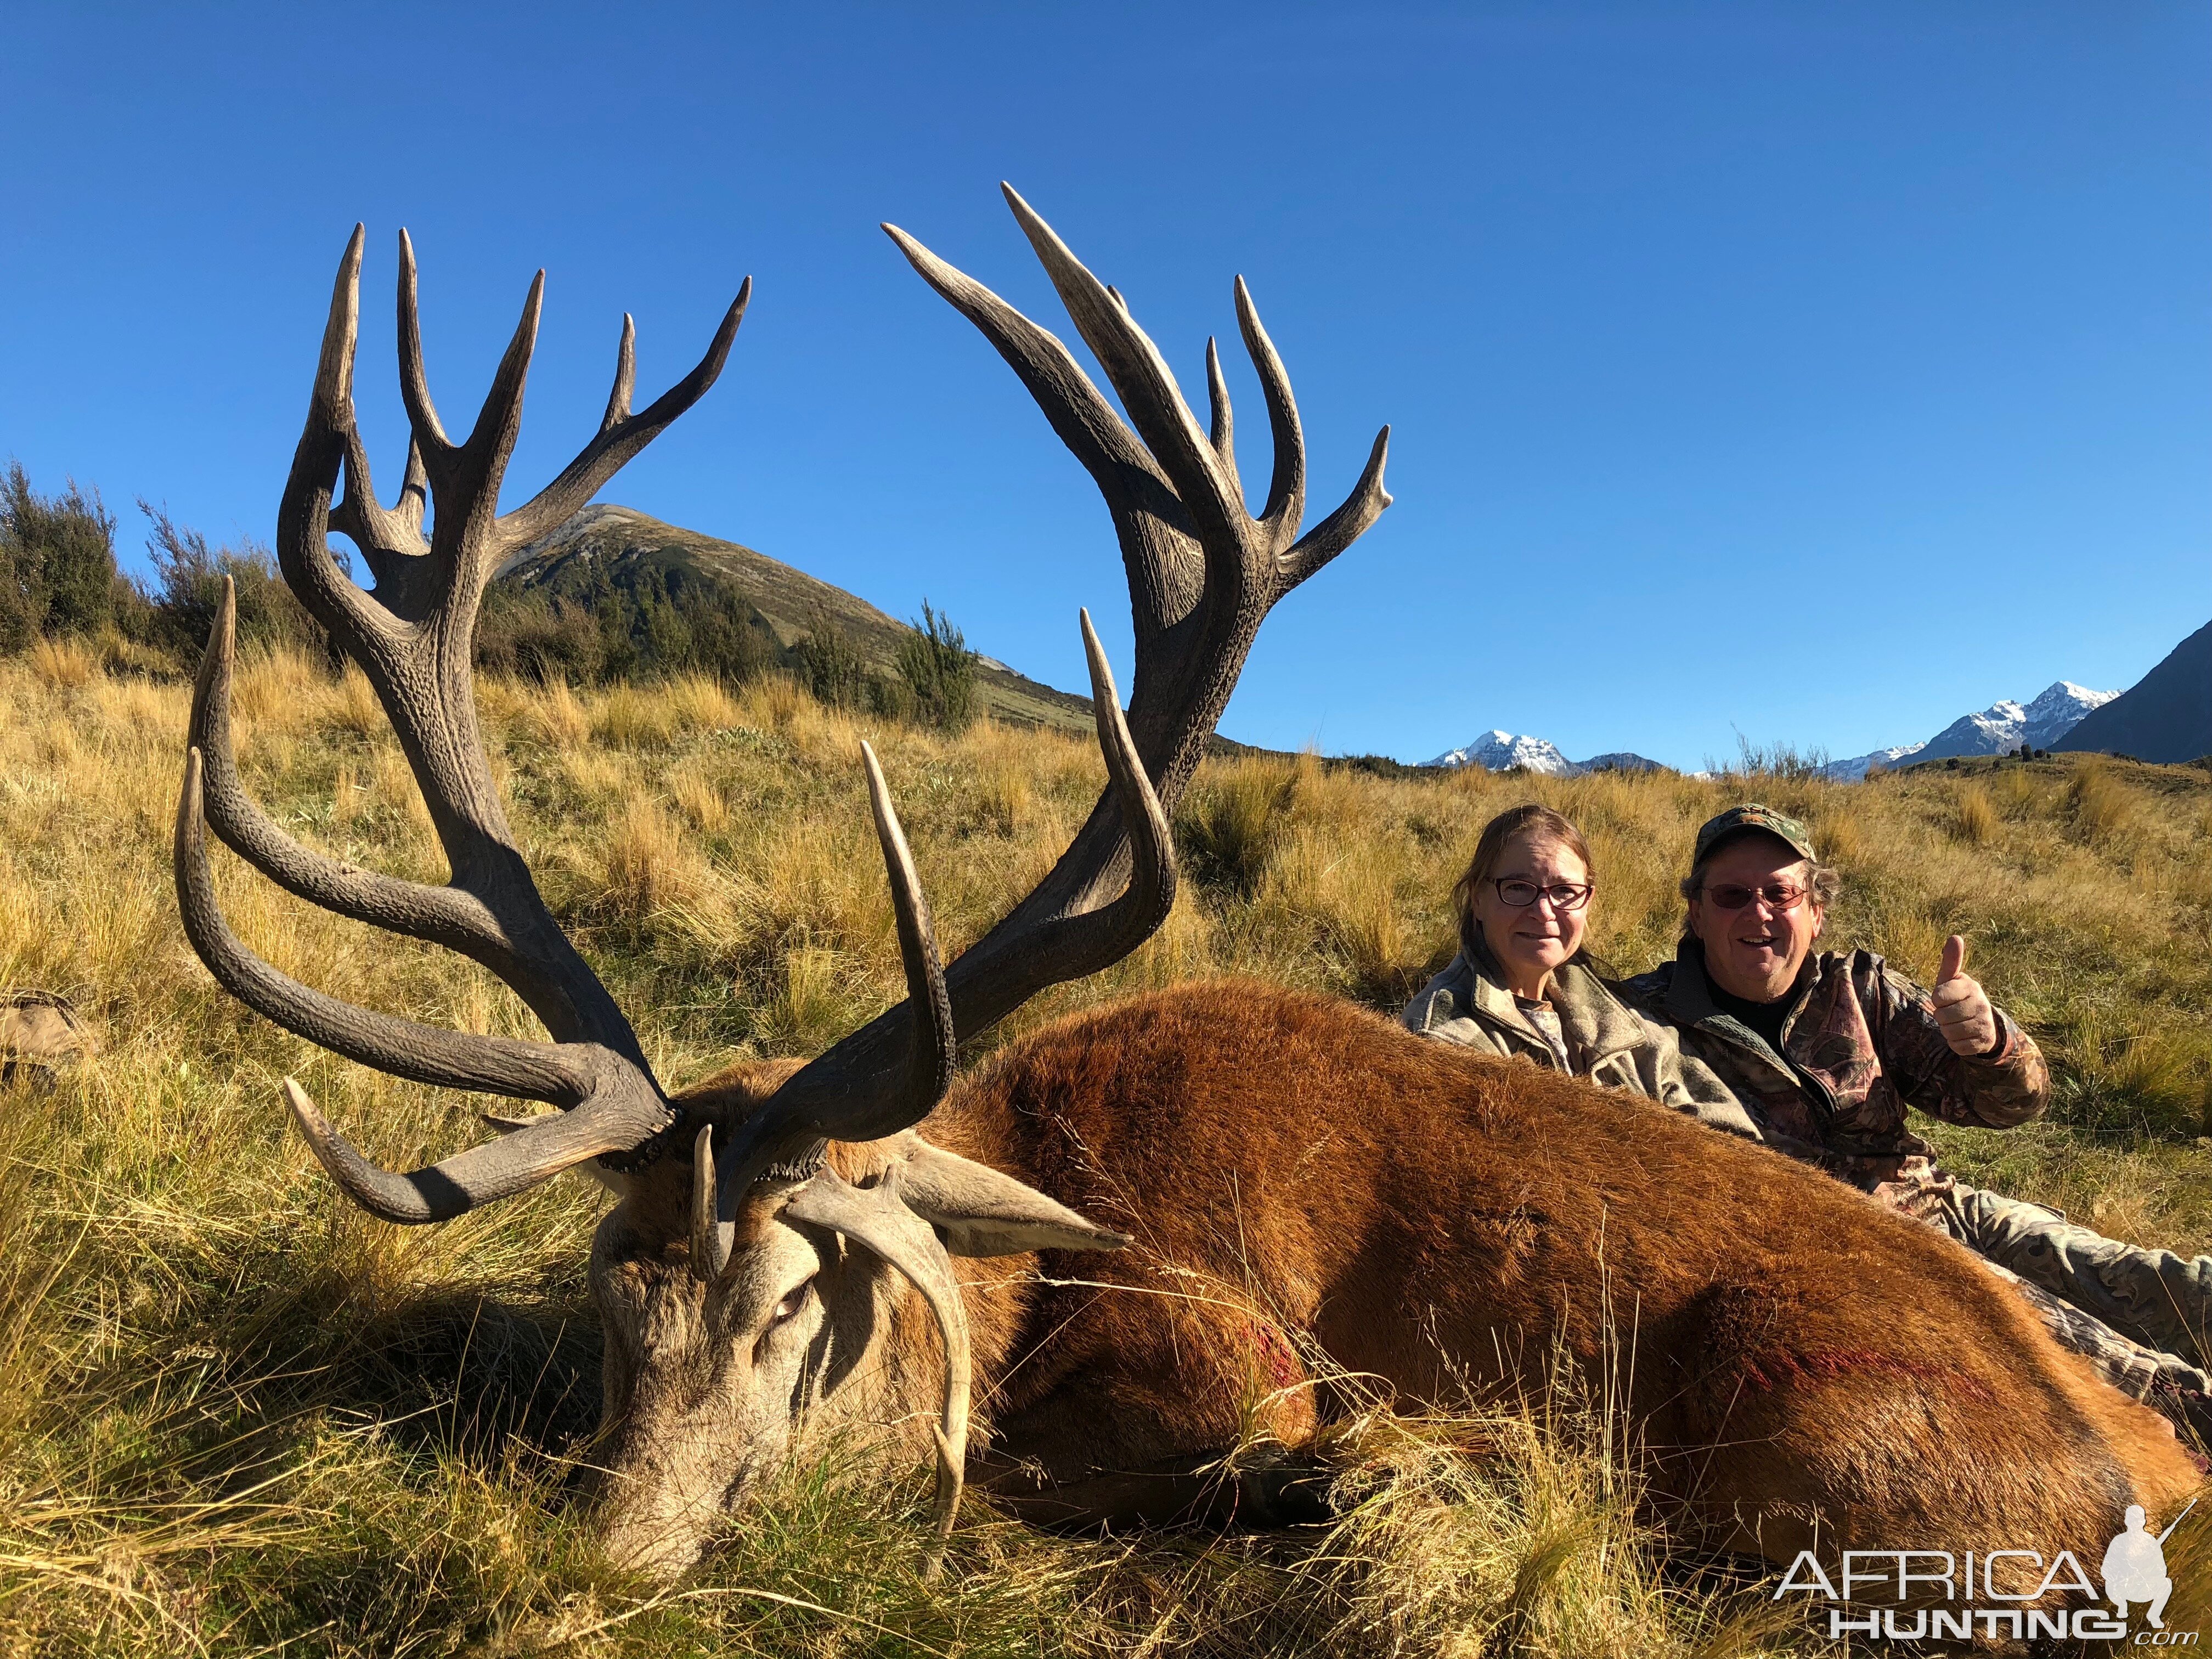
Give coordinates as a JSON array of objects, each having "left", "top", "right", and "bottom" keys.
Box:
[{"left": 716, "top": 186, "right": 1389, "bottom": 1256}]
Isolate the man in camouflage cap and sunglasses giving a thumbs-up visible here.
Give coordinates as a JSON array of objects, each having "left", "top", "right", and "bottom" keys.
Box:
[{"left": 1621, "top": 805, "right": 2212, "bottom": 1431}]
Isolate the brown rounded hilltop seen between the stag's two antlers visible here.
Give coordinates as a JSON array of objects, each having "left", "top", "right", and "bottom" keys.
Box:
[{"left": 498, "top": 504, "right": 1093, "bottom": 735}]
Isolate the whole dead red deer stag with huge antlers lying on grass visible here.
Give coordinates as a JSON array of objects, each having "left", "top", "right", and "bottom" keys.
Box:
[{"left": 177, "top": 190, "right": 2194, "bottom": 1573}]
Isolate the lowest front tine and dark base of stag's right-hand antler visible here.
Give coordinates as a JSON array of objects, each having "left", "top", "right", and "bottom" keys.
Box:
[{"left": 714, "top": 743, "right": 956, "bottom": 1261}]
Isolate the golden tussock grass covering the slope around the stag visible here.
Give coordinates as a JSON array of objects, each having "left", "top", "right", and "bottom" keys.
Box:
[{"left": 0, "top": 648, "right": 2212, "bottom": 1659}]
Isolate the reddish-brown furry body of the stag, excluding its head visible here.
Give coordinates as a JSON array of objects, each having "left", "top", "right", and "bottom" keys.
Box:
[{"left": 626, "top": 982, "right": 2197, "bottom": 1560}]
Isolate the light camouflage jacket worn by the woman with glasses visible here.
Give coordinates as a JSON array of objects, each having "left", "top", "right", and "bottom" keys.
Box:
[{"left": 1400, "top": 951, "right": 1758, "bottom": 1142}]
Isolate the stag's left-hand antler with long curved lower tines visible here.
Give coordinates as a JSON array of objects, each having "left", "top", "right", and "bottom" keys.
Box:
[{"left": 177, "top": 225, "right": 752, "bottom": 1221}]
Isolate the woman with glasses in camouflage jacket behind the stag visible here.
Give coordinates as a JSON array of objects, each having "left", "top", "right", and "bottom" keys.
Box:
[{"left": 1404, "top": 803, "right": 1758, "bottom": 1142}]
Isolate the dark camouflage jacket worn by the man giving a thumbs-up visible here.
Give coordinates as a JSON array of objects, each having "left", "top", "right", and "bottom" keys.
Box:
[{"left": 1619, "top": 940, "right": 2051, "bottom": 1219}]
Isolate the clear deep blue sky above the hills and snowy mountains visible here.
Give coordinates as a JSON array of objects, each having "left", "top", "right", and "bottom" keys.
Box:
[{"left": 0, "top": 0, "right": 2212, "bottom": 765}]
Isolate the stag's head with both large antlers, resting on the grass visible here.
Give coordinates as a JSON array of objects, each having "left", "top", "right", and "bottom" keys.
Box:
[{"left": 175, "top": 188, "right": 1389, "bottom": 1571}]
